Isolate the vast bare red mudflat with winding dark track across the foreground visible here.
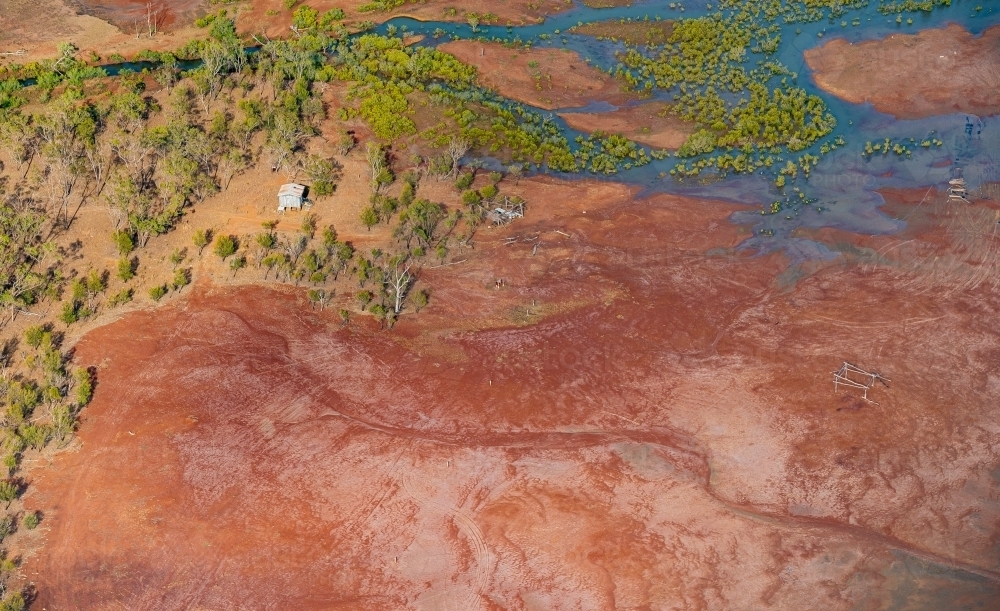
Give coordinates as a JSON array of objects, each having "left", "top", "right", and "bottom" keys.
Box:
[{"left": 15, "top": 180, "right": 1000, "bottom": 611}]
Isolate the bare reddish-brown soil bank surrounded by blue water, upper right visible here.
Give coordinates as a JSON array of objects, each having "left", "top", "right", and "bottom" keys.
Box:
[{"left": 805, "top": 24, "right": 1000, "bottom": 119}]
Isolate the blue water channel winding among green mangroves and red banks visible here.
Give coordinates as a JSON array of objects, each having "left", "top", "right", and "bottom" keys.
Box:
[{"left": 377, "top": 0, "right": 1000, "bottom": 260}]
